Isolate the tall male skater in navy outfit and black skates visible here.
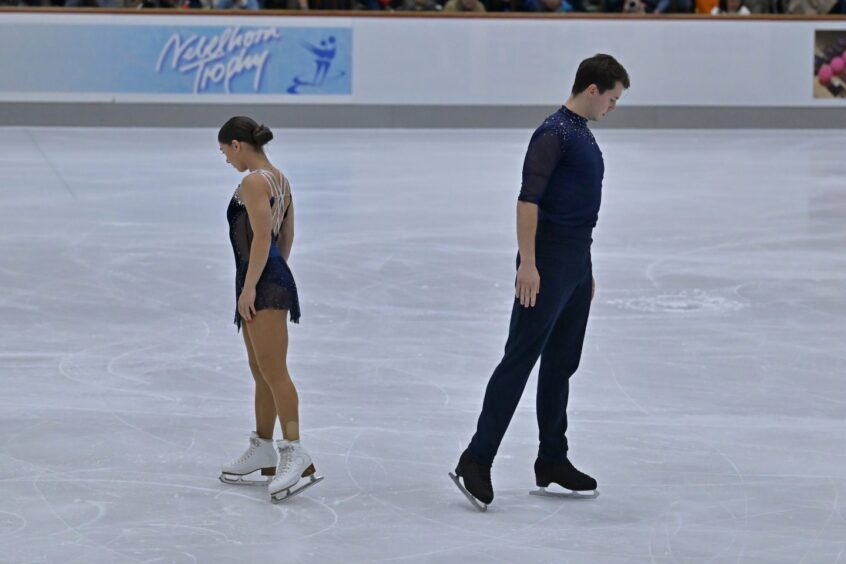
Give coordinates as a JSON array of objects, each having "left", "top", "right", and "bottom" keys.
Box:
[{"left": 450, "top": 55, "right": 629, "bottom": 511}]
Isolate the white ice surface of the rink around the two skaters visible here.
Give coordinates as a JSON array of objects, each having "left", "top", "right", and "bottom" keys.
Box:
[{"left": 0, "top": 128, "right": 846, "bottom": 564}]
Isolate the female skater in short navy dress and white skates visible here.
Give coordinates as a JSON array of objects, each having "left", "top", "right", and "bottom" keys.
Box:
[{"left": 217, "top": 117, "right": 322, "bottom": 501}]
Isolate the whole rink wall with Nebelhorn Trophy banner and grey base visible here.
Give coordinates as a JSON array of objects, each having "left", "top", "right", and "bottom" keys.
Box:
[{"left": 0, "top": 11, "right": 846, "bottom": 128}]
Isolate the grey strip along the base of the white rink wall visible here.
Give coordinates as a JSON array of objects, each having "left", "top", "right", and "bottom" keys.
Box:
[{"left": 0, "top": 102, "right": 846, "bottom": 129}]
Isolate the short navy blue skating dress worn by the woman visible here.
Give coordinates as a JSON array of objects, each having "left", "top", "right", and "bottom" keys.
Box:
[{"left": 226, "top": 172, "right": 300, "bottom": 330}]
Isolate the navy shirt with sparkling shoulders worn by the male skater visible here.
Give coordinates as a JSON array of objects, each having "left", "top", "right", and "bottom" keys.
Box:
[{"left": 518, "top": 107, "right": 605, "bottom": 228}]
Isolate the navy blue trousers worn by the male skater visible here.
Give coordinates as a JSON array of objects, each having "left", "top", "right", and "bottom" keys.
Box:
[{"left": 469, "top": 223, "right": 593, "bottom": 464}]
